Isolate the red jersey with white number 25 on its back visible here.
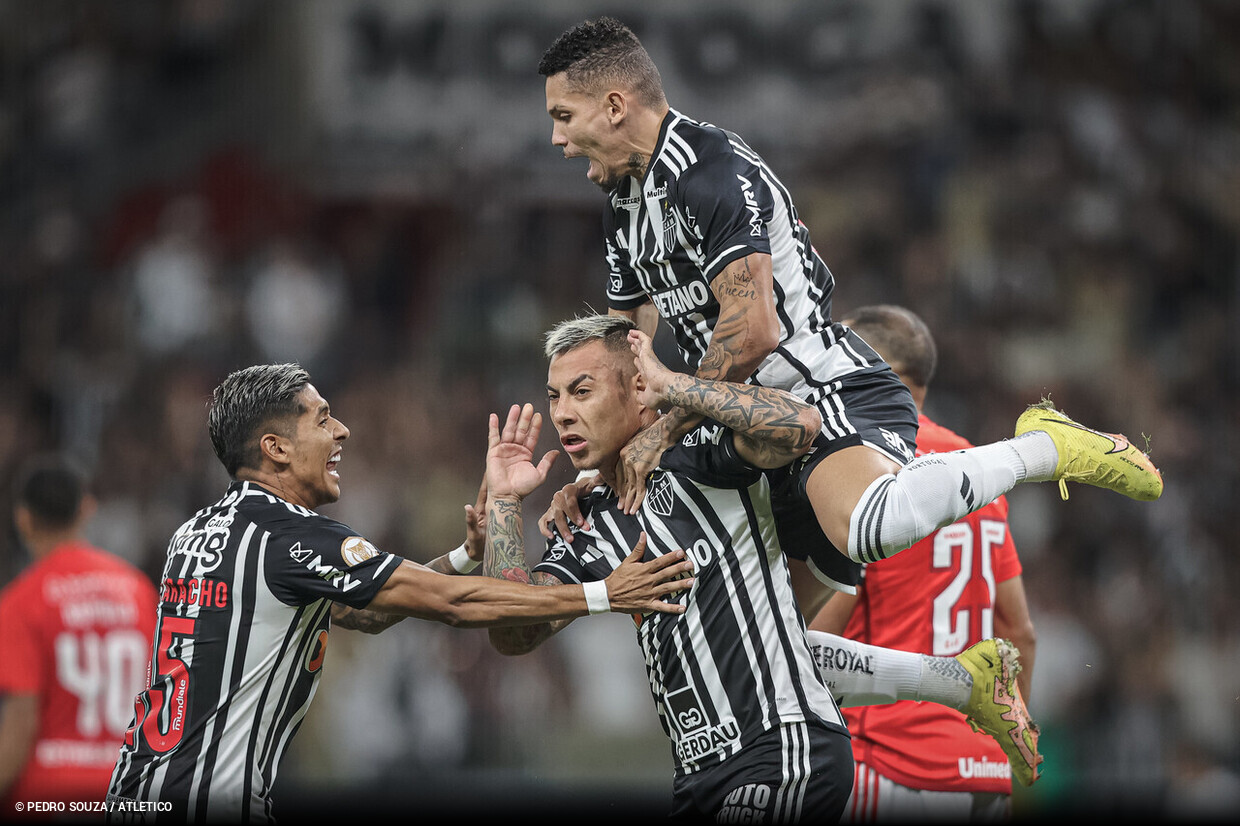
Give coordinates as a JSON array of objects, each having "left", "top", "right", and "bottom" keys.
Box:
[{"left": 843, "top": 415, "right": 1021, "bottom": 794}]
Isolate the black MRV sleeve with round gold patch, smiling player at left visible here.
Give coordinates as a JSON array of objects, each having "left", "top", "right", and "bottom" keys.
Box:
[{"left": 264, "top": 517, "right": 401, "bottom": 608}]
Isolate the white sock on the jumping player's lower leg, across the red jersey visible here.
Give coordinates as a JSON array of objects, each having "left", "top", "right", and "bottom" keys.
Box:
[{"left": 807, "top": 631, "right": 973, "bottom": 711}]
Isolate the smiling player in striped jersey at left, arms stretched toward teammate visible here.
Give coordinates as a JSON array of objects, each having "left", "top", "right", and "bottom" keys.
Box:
[{"left": 108, "top": 365, "right": 692, "bottom": 822}]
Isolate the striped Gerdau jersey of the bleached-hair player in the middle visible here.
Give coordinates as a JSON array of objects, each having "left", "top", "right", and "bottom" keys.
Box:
[{"left": 534, "top": 420, "right": 846, "bottom": 774}]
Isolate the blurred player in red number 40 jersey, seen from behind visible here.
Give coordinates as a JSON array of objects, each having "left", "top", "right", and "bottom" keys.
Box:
[{"left": 0, "top": 456, "right": 156, "bottom": 816}]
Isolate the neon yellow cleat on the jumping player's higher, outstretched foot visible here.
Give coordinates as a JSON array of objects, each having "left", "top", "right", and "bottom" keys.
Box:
[{"left": 1016, "top": 401, "right": 1162, "bottom": 502}]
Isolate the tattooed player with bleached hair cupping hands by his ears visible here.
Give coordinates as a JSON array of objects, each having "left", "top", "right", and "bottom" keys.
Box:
[{"left": 484, "top": 315, "right": 852, "bottom": 822}]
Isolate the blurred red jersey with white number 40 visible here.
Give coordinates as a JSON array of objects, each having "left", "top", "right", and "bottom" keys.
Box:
[{"left": 0, "top": 543, "right": 156, "bottom": 811}]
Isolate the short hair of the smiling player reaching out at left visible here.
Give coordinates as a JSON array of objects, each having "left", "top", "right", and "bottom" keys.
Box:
[{"left": 207, "top": 363, "right": 310, "bottom": 479}]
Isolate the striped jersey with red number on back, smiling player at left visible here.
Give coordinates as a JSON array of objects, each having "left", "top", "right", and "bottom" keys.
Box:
[{"left": 108, "top": 482, "right": 401, "bottom": 822}]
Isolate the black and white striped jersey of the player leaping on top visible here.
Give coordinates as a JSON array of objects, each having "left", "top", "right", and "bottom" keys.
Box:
[{"left": 603, "top": 109, "right": 882, "bottom": 404}]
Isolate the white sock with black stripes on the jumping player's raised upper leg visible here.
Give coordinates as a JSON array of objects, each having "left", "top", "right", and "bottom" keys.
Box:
[{"left": 848, "top": 432, "right": 1041, "bottom": 562}]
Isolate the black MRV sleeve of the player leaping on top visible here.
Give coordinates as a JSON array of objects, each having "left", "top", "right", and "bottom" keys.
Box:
[{"left": 676, "top": 154, "right": 775, "bottom": 282}]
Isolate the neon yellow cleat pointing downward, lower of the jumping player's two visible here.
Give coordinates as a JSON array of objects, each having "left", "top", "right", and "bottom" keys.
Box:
[{"left": 956, "top": 637, "right": 1043, "bottom": 786}]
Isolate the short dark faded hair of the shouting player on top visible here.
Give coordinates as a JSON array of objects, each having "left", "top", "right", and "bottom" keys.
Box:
[{"left": 538, "top": 17, "right": 667, "bottom": 107}]
